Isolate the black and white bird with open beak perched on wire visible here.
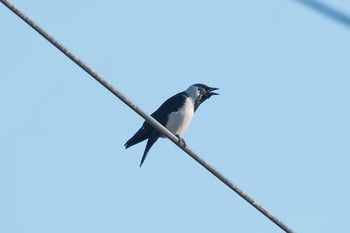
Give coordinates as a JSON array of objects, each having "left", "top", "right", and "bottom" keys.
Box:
[{"left": 124, "top": 83, "right": 219, "bottom": 167}]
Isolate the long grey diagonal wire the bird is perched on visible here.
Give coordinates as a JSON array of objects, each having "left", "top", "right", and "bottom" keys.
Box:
[{"left": 0, "top": 0, "right": 293, "bottom": 233}]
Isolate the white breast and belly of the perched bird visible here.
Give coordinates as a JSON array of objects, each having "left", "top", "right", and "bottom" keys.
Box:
[{"left": 165, "top": 98, "right": 194, "bottom": 136}]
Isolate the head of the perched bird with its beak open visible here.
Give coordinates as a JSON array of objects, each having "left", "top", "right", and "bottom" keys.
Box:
[{"left": 185, "top": 83, "right": 219, "bottom": 110}]
